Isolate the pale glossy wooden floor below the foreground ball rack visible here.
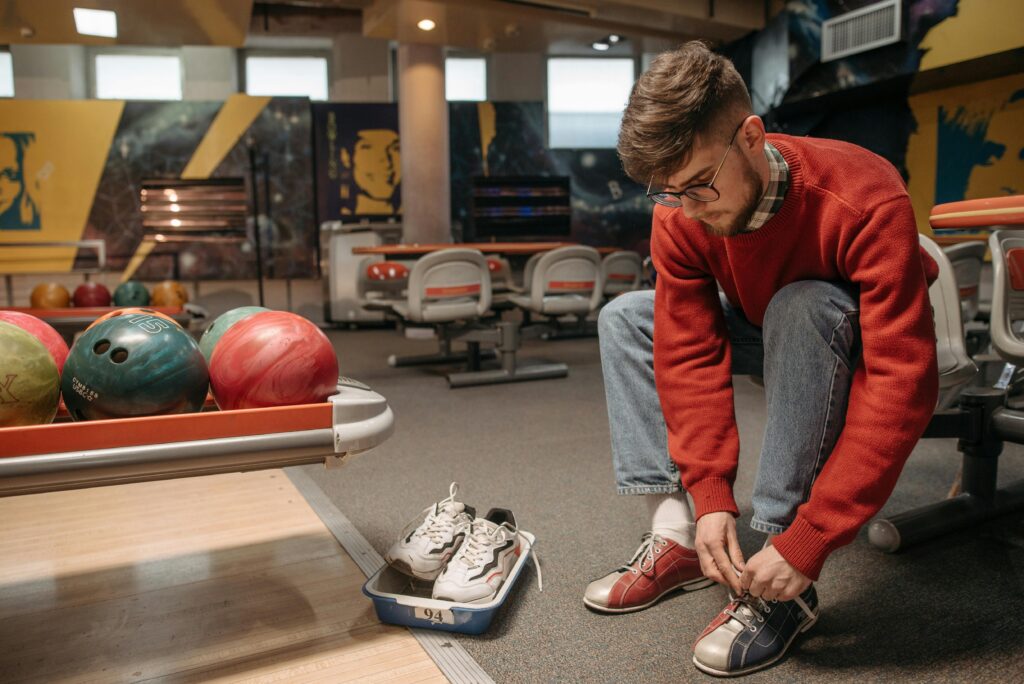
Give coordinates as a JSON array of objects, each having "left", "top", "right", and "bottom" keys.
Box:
[{"left": 0, "top": 470, "right": 445, "bottom": 684}]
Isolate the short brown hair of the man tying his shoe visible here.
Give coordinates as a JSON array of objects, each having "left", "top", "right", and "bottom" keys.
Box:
[{"left": 618, "top": 41, "right": 751, "bottom": 185}]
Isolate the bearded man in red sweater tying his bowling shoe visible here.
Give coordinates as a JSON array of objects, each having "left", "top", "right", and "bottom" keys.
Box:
[{"left": 584, "top": 43, "right": 938, "bottom": 675}]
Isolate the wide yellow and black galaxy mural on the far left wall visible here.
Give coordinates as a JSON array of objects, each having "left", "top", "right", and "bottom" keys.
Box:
[{"left": 0, "top": 95, "right": 316, "bottom": 280}]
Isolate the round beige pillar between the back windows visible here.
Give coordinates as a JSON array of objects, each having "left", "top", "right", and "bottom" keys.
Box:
[{"left": 398, "top": 44, "right": 452, "bottom": 244}]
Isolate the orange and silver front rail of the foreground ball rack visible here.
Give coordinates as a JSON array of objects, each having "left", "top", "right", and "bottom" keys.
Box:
[{"left": 0, "top": 379, "right": 394, "bottom": 497}]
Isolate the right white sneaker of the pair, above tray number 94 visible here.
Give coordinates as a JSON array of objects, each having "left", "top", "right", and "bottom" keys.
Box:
[{"left": 432, "top": 508, "right": 521, "bottom": 603}]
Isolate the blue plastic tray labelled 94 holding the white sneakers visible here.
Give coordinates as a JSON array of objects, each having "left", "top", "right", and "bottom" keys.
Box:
[{"left": 362, "top": 531, "right": 537, "bottom": 634}]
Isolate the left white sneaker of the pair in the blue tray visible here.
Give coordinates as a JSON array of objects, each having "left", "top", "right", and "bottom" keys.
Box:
[{"left": 384, "top": 482, "right": 476, "bottom": 580}]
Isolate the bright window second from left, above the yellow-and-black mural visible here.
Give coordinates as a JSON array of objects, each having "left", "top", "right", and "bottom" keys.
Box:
[{"left": 94, "top": 54, "right": 181, "bottom": 99}]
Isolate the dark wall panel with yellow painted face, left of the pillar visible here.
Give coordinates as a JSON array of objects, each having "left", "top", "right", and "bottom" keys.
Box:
[{"left": 312, "top": 102, "right": 401, "bottom": 222}]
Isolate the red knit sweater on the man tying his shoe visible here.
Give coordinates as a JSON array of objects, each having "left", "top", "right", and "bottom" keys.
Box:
[{"left": 651, "top": 135, "right": 938, "bottom": 580}]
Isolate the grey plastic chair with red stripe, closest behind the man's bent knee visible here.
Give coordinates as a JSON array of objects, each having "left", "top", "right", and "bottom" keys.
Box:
[{"left": 510, "top": 245, "right": 604, "bottom": 339}]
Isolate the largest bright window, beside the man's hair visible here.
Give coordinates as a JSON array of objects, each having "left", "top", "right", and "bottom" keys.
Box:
[{"left": 548, "top": 57, "right": 634, "bottom": 148}]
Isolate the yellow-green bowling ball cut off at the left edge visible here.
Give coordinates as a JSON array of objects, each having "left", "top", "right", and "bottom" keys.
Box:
[{"left": 0, "top": 322, "right": 60, "bottom": 427}]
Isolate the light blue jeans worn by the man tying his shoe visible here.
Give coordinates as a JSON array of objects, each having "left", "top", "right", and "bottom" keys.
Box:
[{"left": 598, "top": 281, "right": 860, "bottom": 535}]
